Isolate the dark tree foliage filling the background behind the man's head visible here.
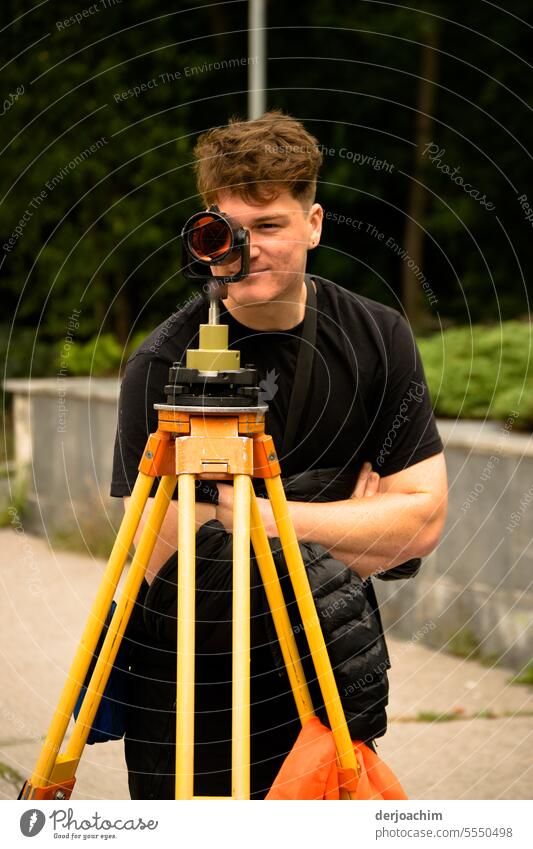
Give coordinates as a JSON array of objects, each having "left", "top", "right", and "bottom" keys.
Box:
[{"left": 0, "top": 0, "right": 533, "bottom": 373}]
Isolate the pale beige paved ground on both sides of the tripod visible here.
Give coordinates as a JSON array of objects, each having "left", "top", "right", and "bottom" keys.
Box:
[{"left": 0, "top": 530, "right": 533, "bottom": 799}]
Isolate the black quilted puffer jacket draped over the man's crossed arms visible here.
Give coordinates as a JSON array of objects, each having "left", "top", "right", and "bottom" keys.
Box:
[{"left": 143, "top": 470, "right": 420, "bottom": 740}]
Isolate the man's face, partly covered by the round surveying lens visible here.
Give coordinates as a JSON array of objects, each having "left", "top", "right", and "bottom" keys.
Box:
[{"left": 211, "top": 186, "right": 323, "bottom": 306}]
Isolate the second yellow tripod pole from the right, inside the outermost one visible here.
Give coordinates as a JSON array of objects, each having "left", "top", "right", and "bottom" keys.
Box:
[{"left": 250, "top": 482, "right": 314, "bottom": 725}]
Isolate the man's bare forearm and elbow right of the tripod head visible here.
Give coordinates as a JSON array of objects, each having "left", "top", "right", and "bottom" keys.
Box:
[{"left": 260, "top": 492, "right": 435, "bottom": 577}]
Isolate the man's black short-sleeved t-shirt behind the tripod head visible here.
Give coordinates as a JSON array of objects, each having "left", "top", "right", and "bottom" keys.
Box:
[{"left": 111, "top": 276, "right": 443, "bottom": 501}]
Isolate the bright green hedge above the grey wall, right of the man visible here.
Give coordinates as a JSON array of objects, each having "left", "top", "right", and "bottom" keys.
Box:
[{"left": 417, "top": 321, "right": 533, "bottom": 430}]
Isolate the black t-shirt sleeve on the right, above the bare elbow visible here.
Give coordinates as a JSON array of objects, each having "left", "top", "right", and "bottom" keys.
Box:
[{"left": 369, "top": 315, "right": 443, "bottom": 477}]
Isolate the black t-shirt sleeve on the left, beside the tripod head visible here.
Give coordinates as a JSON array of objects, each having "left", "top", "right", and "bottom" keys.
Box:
[{"left": 110, "top": 353, "right": 218, "bottom": 504}]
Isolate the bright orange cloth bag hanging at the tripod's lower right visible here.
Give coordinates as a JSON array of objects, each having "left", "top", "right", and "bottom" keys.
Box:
[{"left": 266, "top": 716, "right": 407, "bottom": 801}]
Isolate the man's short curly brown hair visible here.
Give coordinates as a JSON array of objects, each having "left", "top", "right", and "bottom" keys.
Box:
[{"left": 194, "top": 109, "right": 323, "bottom": 208}]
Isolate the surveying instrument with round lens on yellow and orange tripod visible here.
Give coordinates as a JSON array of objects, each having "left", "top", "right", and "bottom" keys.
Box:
[{"left": 19, "top": 206, "right": 359, "bottom": 800}]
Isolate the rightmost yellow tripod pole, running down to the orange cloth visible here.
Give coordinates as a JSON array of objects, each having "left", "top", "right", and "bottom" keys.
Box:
[{"left": 265, "top": 475, "right": 358, "bottom": 796}]
